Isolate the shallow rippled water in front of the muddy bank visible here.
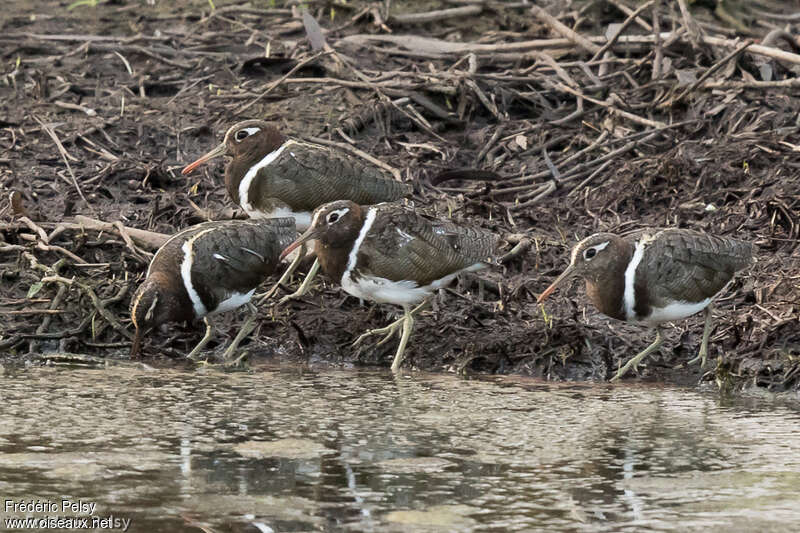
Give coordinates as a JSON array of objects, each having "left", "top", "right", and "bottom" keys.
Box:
[{"left": 0, "top": 367, "right": 800, "bottom": 532}]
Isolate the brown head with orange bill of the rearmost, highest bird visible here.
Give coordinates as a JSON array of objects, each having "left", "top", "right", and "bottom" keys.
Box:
[{"left": 182, "top": 120, "right": 286, "bottom": 176}]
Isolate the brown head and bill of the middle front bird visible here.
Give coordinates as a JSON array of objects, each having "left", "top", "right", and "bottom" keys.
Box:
[{"left": 281, "top": 200, "right": 364, "bottom": 260}]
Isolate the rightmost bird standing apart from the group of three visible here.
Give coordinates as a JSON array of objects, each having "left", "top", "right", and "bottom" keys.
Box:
[{"left": 537, "top": 228, "right": 755, "bottom": 381}]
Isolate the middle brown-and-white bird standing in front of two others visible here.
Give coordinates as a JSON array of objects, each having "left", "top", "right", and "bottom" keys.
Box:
[{"left": 281, "top": 200, "right": 497, "bottom": 372}]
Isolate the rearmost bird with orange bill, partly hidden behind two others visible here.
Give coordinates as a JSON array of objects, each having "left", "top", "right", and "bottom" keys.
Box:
[{"left": 182, "top": 120, "right": 411, "bottom": 303}]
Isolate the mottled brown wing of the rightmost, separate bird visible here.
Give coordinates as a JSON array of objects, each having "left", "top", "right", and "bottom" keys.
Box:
[{"left": 637, "top": 229, "right": 753, "bottom": 307}]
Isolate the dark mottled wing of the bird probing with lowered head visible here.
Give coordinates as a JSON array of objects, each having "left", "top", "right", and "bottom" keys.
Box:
[{"left": 192, "top": 218, "right": 296, "bottom": 307}]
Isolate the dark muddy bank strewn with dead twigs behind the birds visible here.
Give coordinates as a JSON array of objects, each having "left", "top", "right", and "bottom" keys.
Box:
[{"left": 0, "top": 0, "right": 800, "bottom": 390}]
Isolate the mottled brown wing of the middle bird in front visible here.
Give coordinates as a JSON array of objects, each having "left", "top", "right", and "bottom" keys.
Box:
[{"left": 357, "top": 205, "right": 497, "bottom": 286}]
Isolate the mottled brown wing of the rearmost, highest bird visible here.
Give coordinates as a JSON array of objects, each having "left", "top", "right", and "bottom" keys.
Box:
[{"left": 254, "top": 142, "right": 410, "bottom": 211}]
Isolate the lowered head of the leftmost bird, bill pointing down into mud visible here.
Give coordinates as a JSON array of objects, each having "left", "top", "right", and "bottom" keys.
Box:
[{"left": 131, "top": 272, "right": 191, "bottom": 359}]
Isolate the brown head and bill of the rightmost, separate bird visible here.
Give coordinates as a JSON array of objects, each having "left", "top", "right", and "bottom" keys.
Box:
[{"left": 537, "top": 233, "right": 631, "bottom": 306}]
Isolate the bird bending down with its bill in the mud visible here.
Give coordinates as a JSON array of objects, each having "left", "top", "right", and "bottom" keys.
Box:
[{"left": 130, "top": 217, "right": 297, "bottom": 361}]
